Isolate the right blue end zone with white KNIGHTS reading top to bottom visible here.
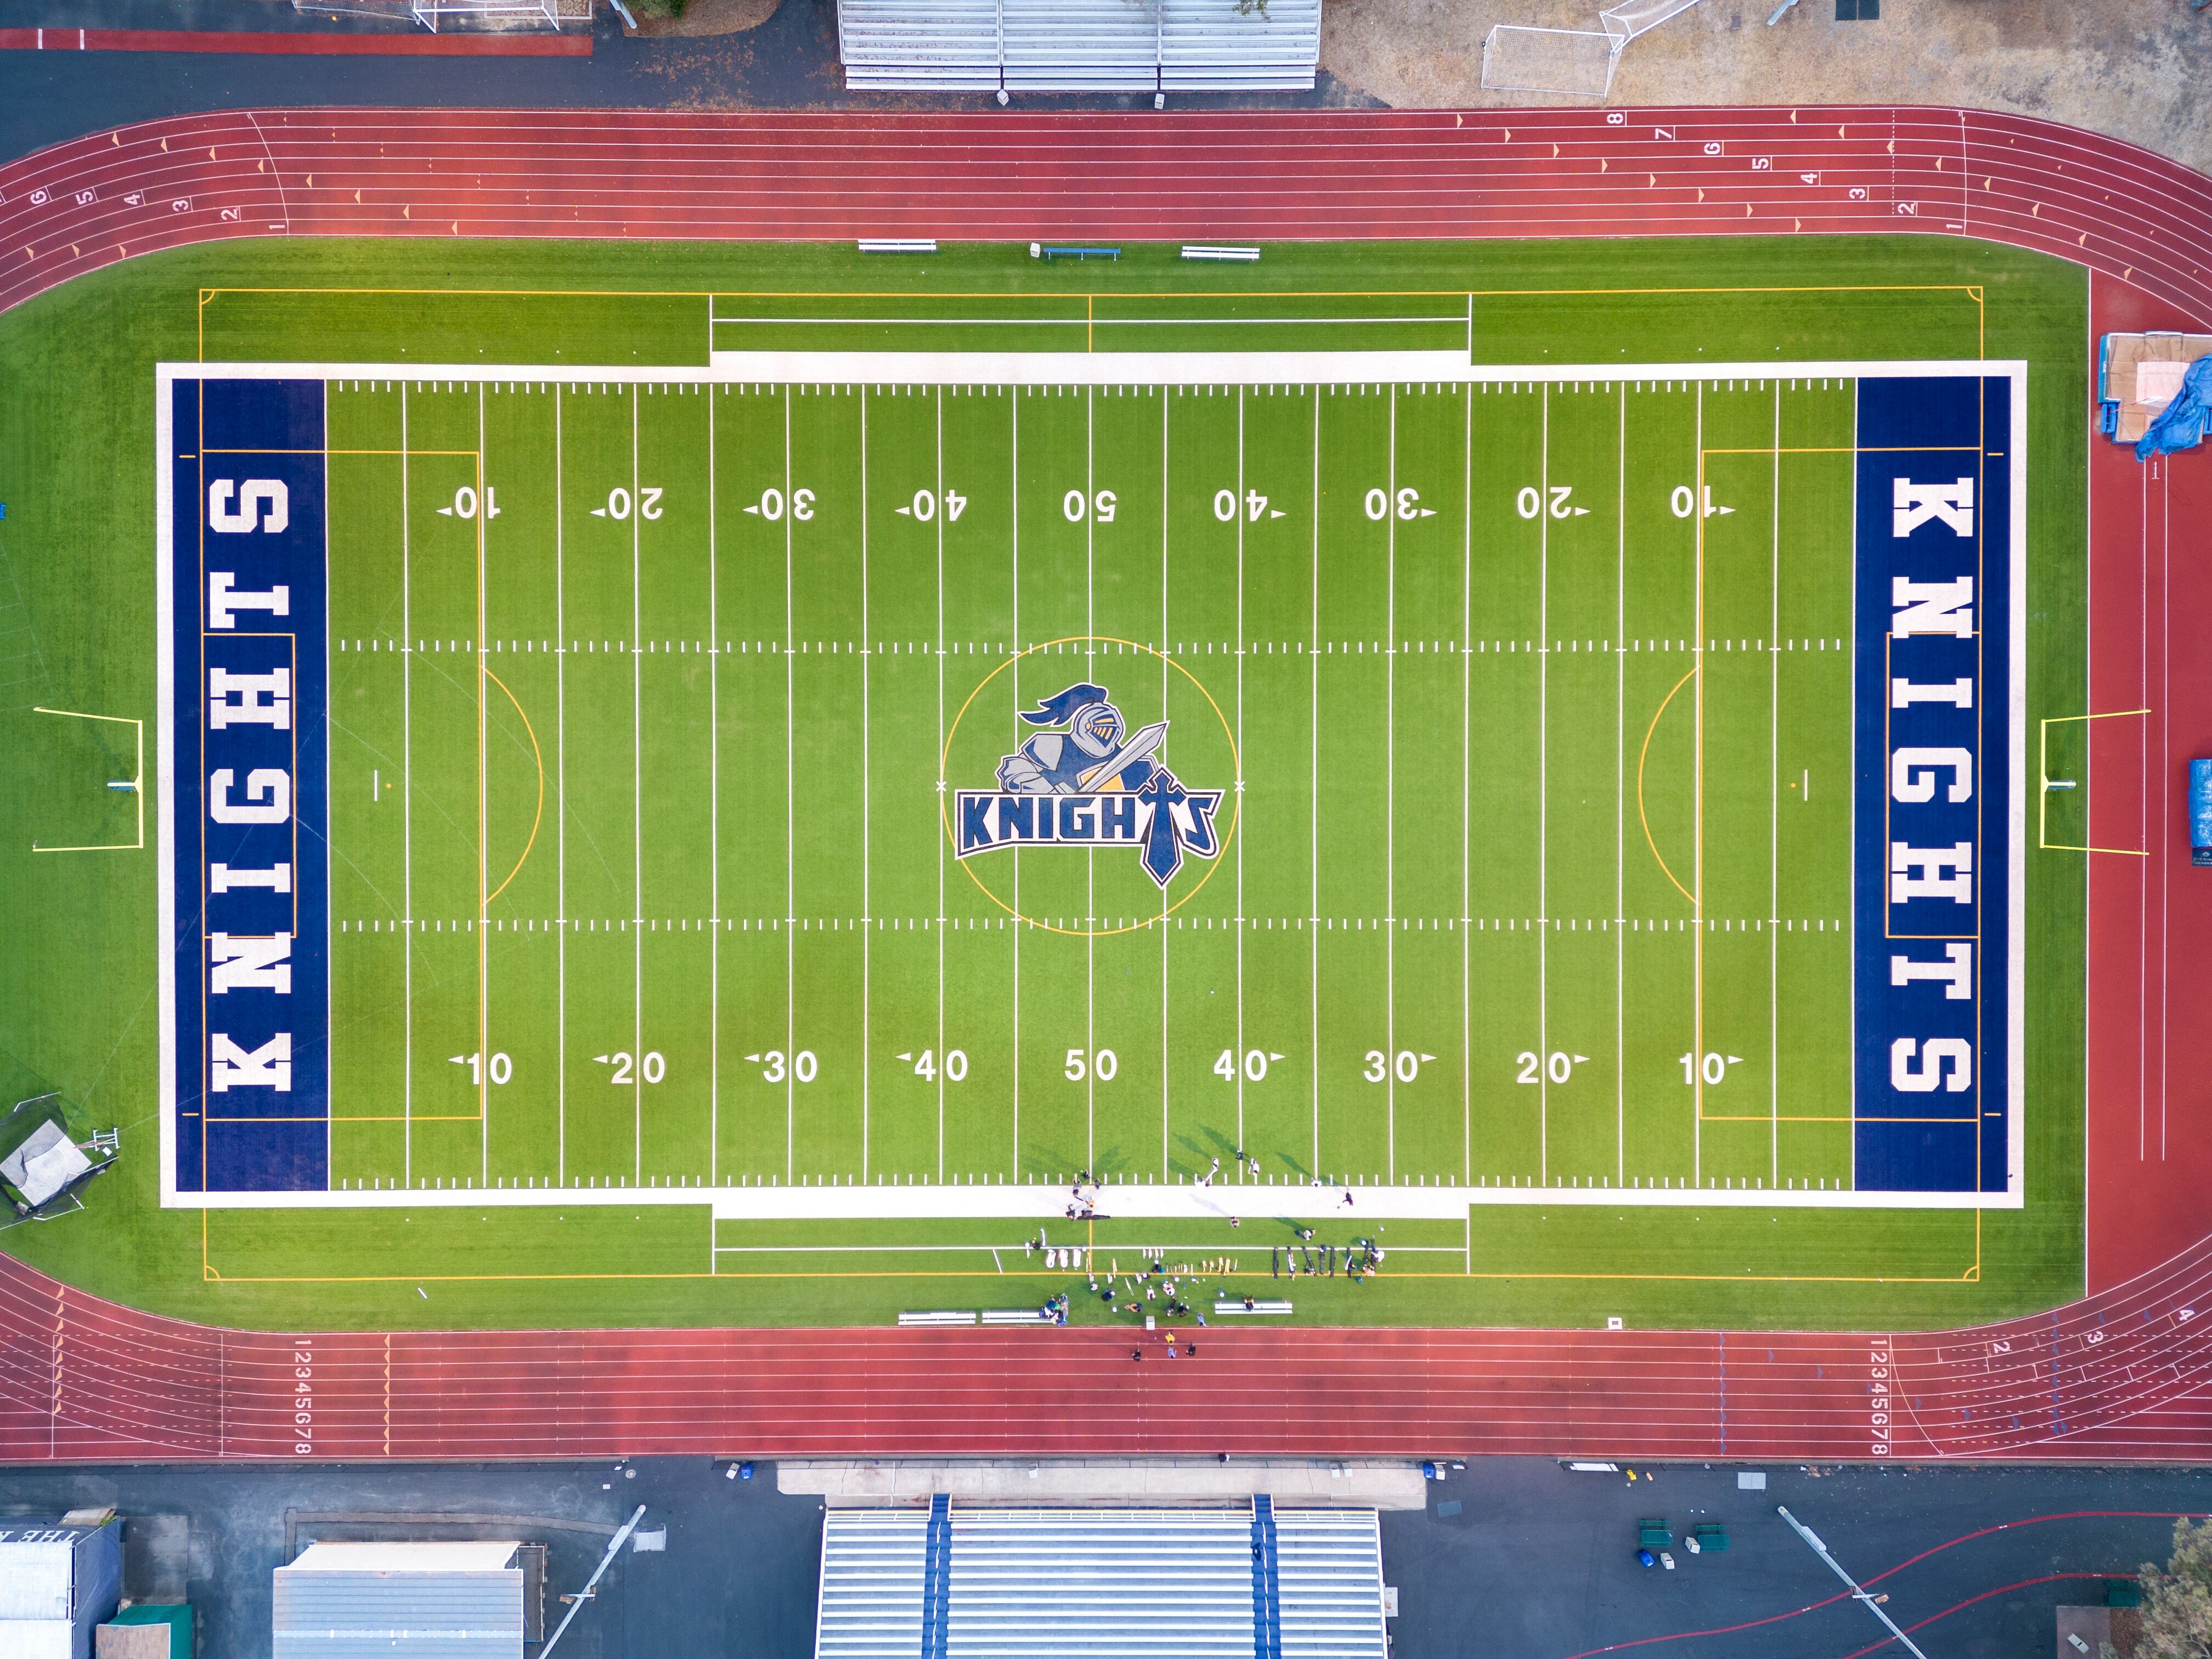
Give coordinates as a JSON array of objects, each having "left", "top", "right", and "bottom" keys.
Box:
[{"left": 1852, "top": 376, "right": 2015, "bottom": 1192}]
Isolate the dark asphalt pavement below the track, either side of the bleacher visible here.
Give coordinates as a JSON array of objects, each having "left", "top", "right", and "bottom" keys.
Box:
[{"left": 0, "top": 1458, "right": 2212, "bottom": 1659}]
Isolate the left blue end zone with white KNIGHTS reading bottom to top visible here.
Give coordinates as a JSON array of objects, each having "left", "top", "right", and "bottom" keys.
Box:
[{"left": 166, "top": 381, "right": 330, "bottom": 1192}]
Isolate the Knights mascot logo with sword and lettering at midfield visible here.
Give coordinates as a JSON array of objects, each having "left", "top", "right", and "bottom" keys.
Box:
[{"left": 953, "top": 684, "right": 1221, "bottom": 887}]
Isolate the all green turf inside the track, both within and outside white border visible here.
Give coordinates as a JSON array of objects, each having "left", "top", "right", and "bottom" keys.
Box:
[{"left": 0, "top": 239, "right": 2086, "bottom": 1325}]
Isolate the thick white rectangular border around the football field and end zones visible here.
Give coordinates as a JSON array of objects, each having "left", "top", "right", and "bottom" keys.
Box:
[{"left": 155, "top": 352, "right": 2028, "bottom": 1221}]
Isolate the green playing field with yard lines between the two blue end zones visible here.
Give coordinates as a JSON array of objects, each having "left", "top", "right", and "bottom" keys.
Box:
[{"left": 307, "top": 381, "right": 1852, "bottom": 1190}]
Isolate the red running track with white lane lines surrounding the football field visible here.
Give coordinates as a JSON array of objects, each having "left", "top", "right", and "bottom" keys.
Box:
[{"left": 0, "top": 109, "right": 2212, "bottom": 1460}]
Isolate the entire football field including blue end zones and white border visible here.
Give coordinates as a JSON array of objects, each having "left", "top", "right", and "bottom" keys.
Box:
[{"left": 155, "top": 352, "right": 2026, "bottom": 1219}]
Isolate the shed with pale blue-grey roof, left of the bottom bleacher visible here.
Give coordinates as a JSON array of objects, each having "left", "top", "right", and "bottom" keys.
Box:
[{"left": 270, "top": 1542, "right": 522, "bottom": 1659}]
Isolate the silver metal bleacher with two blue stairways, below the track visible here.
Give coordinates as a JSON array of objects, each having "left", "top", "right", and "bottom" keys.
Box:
[{"left": 814, "top": 1498, "right": 1385, "bottom": 1659}]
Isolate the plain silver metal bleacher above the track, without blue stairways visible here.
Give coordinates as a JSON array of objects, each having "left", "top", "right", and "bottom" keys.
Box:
[{"left": 838, "top": 0, "right": 1321, "bottom": 93}]
